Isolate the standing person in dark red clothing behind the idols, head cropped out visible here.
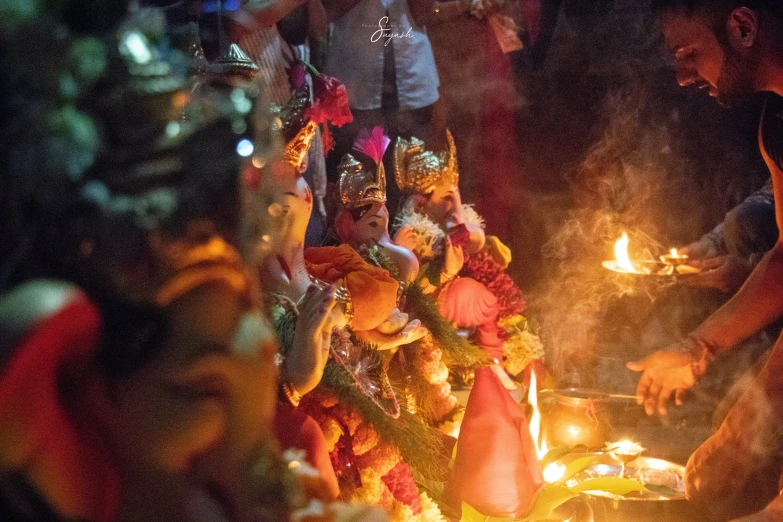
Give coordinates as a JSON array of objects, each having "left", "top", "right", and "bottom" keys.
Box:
[{"left": 425, "top": 0, "right": 541, "bottom": 241}]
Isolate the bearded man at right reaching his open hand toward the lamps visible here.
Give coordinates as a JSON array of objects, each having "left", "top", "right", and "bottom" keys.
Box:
[{"left": 628, "top": 0, "right": 783, "bottom": 520}]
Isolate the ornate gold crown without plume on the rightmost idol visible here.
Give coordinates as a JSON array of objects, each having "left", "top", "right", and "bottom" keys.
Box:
[{"left": 394, "top": 131, "right": 459, "bottom": 194}]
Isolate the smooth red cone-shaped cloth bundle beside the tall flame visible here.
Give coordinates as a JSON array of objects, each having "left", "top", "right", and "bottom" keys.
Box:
[{"left": 446, "top": 368, "right": 544, "bottom": 518}]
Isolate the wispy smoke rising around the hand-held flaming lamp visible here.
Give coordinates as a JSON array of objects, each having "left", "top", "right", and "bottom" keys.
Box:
[{"left": 531, "top": 83, "right": 695, "bottom": 385}]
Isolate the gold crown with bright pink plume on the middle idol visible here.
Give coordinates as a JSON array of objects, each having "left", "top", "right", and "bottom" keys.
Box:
[{"left": 338, "top": 127, "right": 391, "bottom": 209}]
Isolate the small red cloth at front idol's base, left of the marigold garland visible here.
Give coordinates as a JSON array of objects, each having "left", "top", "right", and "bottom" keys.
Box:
[{"left": 275, "top": 403, "right": 340, "bottom": 499}]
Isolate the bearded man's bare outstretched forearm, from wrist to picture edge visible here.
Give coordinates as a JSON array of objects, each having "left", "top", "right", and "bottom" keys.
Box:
[{"left": 693, "top": 242, "right": 783, "bottom": 353}]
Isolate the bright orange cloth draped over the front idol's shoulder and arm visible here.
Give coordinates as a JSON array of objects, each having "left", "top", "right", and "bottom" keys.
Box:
[{"left": 305, "top": 245, "right": 400, "bottom": 332}]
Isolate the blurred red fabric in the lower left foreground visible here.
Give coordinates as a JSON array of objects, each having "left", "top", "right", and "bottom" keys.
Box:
[{"left": 0, "top": 293, "right": 119, "bottom": 521}]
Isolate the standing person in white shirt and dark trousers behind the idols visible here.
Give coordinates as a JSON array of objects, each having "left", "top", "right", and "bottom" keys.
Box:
[{"left": 324, "top": 0, "right": 446, "bottom": 215}]
